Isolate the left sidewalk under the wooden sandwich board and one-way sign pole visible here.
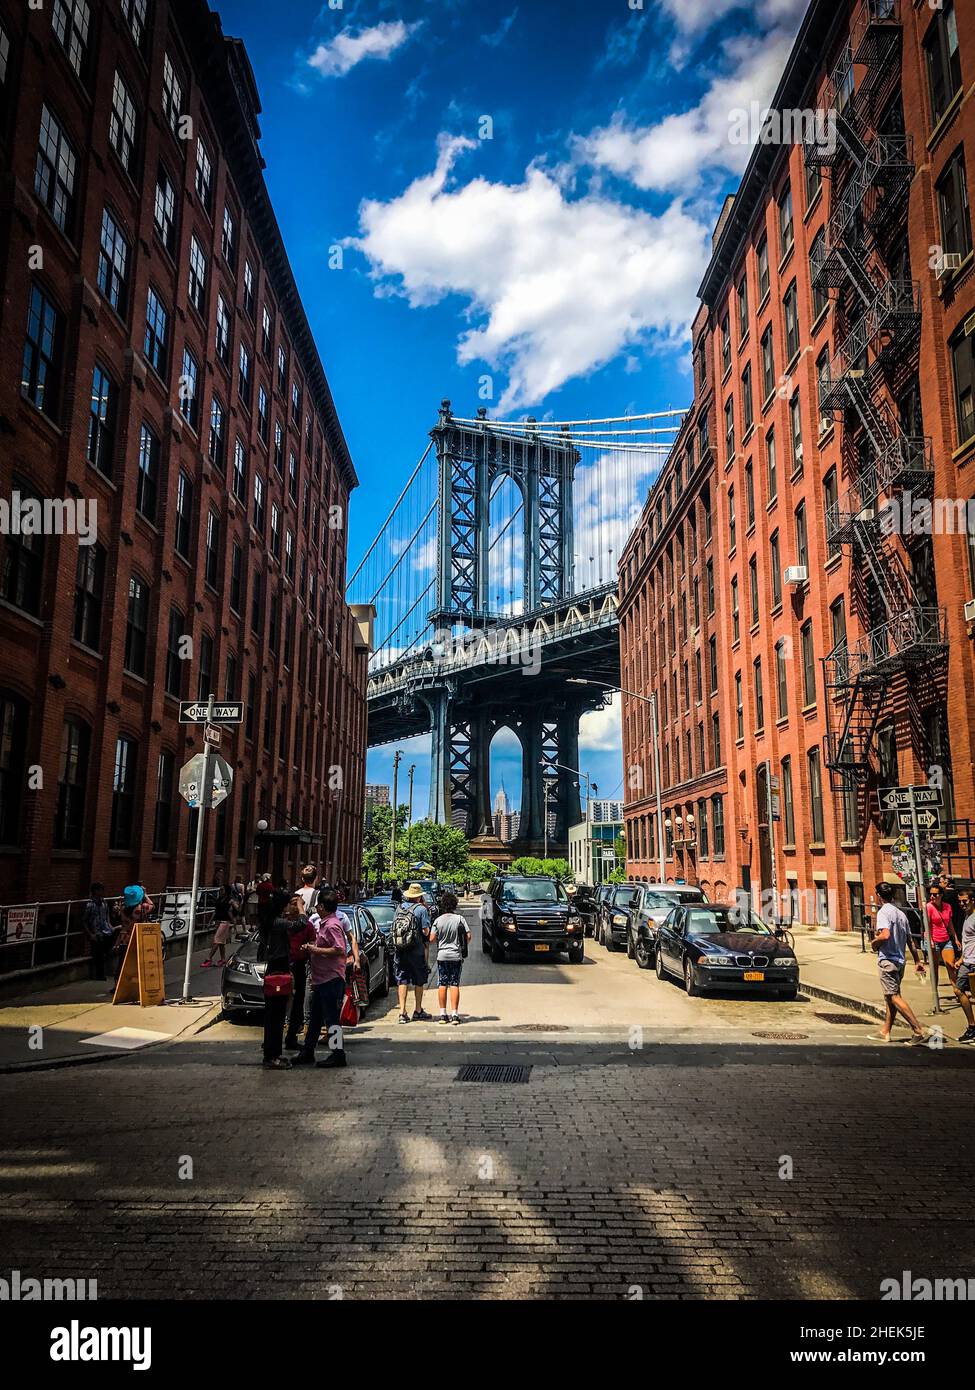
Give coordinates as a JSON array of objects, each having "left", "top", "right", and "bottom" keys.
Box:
[{"left": 0, "top": 947, "right": 221, "bottom": 1072}]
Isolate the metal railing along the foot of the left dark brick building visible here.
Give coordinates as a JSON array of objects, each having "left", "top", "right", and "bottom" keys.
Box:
[{"left": 0, "top": 887, "right": 218, "bottom": 976}]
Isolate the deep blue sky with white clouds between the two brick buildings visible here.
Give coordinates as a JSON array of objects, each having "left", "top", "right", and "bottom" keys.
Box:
[{"left": 217, "top": 0, "right": 805, "bottom": 809}]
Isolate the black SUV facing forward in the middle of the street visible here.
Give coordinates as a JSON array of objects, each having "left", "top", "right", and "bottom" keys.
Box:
[{"left": 481, "top": 873, "right": 586, "bottom": 965}]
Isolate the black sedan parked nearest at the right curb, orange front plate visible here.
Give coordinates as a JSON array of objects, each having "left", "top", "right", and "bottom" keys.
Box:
[{"left": 655, "top": 904, "right": 798, "bottom": 999}]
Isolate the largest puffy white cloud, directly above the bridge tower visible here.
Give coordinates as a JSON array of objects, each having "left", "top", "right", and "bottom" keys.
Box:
[{"left": 353, "top": 136, "right": 709, "bottom": 413}]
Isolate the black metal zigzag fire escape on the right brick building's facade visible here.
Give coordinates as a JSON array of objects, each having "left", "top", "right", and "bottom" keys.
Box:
[{"left": 805, "top": 0, "right": 946, "bottom": 788}]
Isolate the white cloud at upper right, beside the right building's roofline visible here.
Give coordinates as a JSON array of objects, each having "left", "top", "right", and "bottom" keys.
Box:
[{"left": 574, "top": 32, "right": 791, "bottom": 192}]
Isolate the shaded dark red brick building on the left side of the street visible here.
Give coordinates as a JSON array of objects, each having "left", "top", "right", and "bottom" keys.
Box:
[{"left": 0, "top": 0, "right": 369, "bottom": 902}]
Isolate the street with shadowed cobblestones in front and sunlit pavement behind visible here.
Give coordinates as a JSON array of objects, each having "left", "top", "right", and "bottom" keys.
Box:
[{"left": 0, "top": 906, "right": 975, "bottom": 1300}]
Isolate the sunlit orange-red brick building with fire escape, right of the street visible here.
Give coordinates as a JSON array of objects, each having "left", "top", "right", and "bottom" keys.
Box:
[{"left": 620, "top": 0, "right": 975, "bottom": 929}]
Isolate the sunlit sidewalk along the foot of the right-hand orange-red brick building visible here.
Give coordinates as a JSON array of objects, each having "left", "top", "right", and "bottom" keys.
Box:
[{"left": 796, "top": 931, "right": 967, "bottom": 1034}]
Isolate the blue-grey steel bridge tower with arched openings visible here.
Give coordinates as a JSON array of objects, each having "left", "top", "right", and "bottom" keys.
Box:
[{"left": 420, "top": 400, "right": 593, "bottom": 853}]
